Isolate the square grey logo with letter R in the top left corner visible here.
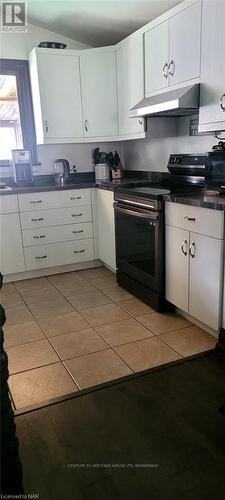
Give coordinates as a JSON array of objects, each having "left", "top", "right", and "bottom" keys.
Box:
[{"left": 0, "top": 2, "right": 27, "bottom": 33}]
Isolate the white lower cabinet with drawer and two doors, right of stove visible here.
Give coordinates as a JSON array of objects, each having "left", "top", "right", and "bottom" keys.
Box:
[{"left": 165, "top": 202, "right": 224, "bottom": 330}]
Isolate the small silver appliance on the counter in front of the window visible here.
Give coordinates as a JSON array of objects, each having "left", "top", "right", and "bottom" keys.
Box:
[{"left": 12, "top": 149, "right": 33, "bottom": 186}]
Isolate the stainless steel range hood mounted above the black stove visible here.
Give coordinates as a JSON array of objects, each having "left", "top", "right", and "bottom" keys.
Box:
[{"left": 129, "top": 84, "right": 199, "bottom": 118}]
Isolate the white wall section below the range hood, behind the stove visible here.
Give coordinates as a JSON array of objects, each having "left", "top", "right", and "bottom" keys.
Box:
[{"left": 124, "top": 117, "right": 218, "bottom": 172}]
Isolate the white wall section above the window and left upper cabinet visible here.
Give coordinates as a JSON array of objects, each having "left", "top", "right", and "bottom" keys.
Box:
[{"left": 0, "top": 24, "right": 88, "bottom": 59}]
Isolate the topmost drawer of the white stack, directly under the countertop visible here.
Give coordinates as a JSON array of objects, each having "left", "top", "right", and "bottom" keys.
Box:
[{"left": 19, "top": 189, "right": 91, "bottom": 212}]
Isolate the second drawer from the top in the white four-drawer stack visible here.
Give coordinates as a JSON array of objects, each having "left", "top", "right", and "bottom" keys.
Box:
[{"left": 20, "top": 206, "right": 92, "bottom": 229}]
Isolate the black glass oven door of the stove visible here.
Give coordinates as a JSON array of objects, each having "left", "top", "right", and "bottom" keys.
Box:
[{"left": 114, "top": 202, "right": 164, "bottom": 292}]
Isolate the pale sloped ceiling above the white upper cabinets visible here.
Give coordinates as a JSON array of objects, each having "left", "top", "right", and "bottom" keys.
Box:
[{"left": 28, "top": 0, "right": 181, "bottom": 47}]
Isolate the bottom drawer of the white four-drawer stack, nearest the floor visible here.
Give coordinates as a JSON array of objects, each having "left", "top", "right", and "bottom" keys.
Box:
[{"left": 24, "top": 239, "right": 94, "bottom": 271}]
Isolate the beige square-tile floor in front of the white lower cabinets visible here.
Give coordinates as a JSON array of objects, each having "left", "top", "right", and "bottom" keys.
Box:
[{"left": 1, "top": 267, "right": 215, "bottom": 409}]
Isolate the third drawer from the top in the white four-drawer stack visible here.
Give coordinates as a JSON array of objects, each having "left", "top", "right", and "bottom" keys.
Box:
[{"left": 23, "top": 222, "right": 93, "bottom": 247}]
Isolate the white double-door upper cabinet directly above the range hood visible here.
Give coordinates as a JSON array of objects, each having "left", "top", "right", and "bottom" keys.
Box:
[{"left": 145, "top": 0, "right": 201, "bottom": 95}]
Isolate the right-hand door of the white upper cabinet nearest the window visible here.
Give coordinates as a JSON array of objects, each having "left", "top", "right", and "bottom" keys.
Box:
[{"left": 80, "top": 51, "right": 118, "bottom": 137}]
